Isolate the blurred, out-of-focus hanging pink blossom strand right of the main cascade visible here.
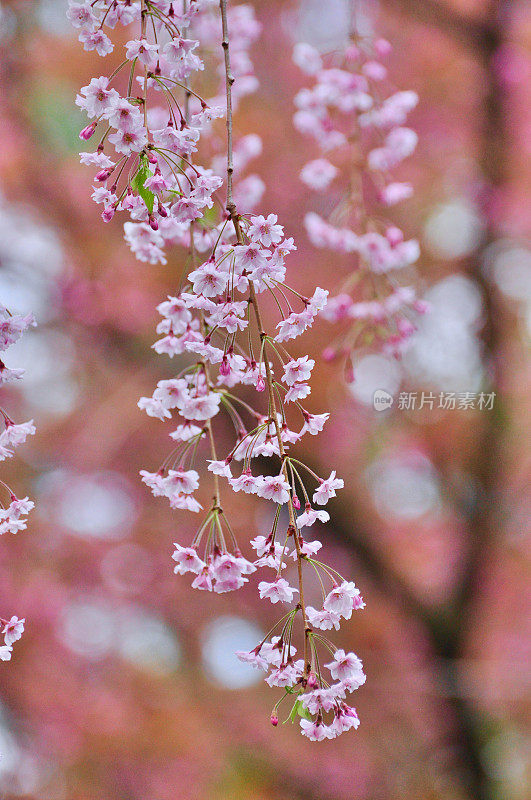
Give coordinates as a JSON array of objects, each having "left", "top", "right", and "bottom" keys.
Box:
[{"left": 293, "top": 21, "right": 426, "bottom": 371}]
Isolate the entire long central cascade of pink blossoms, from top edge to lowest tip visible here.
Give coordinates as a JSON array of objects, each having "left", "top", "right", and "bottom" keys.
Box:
[{"left": 70, "top": 0, "right": 365, "bottom": 740}]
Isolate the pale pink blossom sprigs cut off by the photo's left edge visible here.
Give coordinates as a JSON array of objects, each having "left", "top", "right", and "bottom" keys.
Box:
[{"left": 0, "top": 303, "right": 36, "bottom": 661}]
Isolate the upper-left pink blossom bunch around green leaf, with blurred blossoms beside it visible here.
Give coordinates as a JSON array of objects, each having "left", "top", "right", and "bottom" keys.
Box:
[{"left": 72, "top": 0, "right": 264, "bottom": 264}]
